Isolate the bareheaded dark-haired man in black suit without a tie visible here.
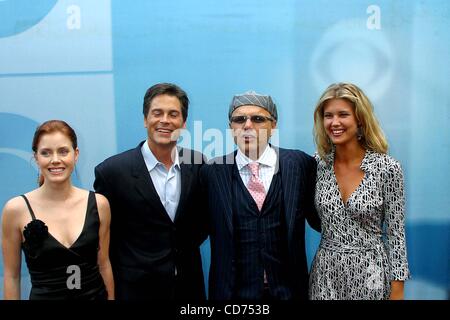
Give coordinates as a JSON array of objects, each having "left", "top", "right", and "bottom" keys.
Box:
[{"left": 94, "top": 83, "right": 206, "bottom": 301}]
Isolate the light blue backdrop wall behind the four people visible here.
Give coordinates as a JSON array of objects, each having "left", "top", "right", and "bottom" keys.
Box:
[{"left": 0, "top": 0, "right": 450, "bottom": 299}]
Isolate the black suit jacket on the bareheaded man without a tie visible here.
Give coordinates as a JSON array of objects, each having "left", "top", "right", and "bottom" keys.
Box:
[{"left": 94, "top": 141, "right": 207, "bottom": 300}]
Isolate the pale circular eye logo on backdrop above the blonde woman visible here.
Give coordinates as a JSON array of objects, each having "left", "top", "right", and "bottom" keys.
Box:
[{"left": 310, "top": 19, "right": 394, "bottom": 98}]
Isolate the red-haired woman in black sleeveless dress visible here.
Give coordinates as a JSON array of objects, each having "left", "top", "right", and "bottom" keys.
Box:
[{"left": 2, "top": 120, "right": 114, "bottom": 300}]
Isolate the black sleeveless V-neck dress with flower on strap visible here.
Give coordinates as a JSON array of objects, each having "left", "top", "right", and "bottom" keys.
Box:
[{"left": 22, "top": 192, "right": 107, "bottom": 300}]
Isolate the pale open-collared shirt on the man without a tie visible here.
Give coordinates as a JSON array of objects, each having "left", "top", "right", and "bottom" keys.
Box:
[{"left": 141, "top": 140, "right": 181, "bottom": 221}]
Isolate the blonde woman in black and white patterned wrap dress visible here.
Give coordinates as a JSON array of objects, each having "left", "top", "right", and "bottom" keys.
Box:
[{"left": 309, "top": 83, "right": 409, "bottom": 300}]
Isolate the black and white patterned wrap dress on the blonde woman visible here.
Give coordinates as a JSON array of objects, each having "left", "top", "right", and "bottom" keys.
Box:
[{"left": 309, "top": 151, "right": 409, "bottom": 300}]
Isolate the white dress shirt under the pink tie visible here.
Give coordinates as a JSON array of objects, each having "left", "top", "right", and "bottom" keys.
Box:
[{"left": 236, "top": 145, "right": 277, "bottom": 194}]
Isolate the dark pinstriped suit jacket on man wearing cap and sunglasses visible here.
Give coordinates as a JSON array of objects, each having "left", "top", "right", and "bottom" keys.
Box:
[{"left": 200, "top": 148, "right": 320, "bottom": 300}]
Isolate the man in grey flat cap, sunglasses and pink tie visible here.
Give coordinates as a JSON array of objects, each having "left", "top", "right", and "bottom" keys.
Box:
[{"left": 200, "top": 91, "right": 320, "bottom": 300}]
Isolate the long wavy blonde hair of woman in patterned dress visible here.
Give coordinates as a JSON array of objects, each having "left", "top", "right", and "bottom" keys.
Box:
[{"left": 314, "top": 82, "right": 388, "bottom": 159}]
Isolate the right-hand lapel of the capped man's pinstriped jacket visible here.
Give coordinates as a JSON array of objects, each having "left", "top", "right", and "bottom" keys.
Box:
[{"left": 277, "top": 149, "right": 300, "bottom": 240}]
